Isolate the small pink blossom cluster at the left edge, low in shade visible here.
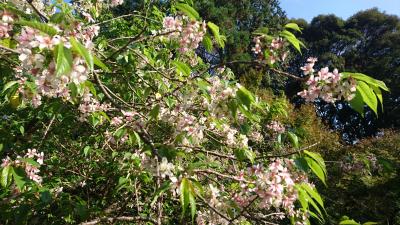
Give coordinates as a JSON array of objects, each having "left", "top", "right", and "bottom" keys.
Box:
[{"left": 1, "top": 149, "right": 44, "bottom": 183}]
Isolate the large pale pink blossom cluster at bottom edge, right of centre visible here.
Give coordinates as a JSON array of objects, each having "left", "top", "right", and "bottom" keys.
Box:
[{"left": 197, "top": 159, "right": 313, "bottom": 225}]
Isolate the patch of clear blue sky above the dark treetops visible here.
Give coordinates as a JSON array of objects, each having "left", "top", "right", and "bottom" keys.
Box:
[{"left": 281, "top": 0, "right": 400, "bottom": 22}]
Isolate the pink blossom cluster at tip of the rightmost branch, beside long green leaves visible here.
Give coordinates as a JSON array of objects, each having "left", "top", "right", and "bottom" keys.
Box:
[{"left": 297, "top": 58, "right": 357, "bottom": 103}]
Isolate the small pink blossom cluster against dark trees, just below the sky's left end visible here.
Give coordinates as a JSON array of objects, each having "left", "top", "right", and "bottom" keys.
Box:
[{"left": 251, "top": 36, "right": 289, "bottom": 64}]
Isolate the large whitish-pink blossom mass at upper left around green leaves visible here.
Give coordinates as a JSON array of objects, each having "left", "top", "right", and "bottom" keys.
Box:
[{"left": 7, "top": 16, "right": 99, "bottom": 107}]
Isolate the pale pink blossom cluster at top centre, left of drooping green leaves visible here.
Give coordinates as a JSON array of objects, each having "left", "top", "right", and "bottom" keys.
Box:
[{"left": 163, "top": 17, "right": 207, "bottom": 53}]
